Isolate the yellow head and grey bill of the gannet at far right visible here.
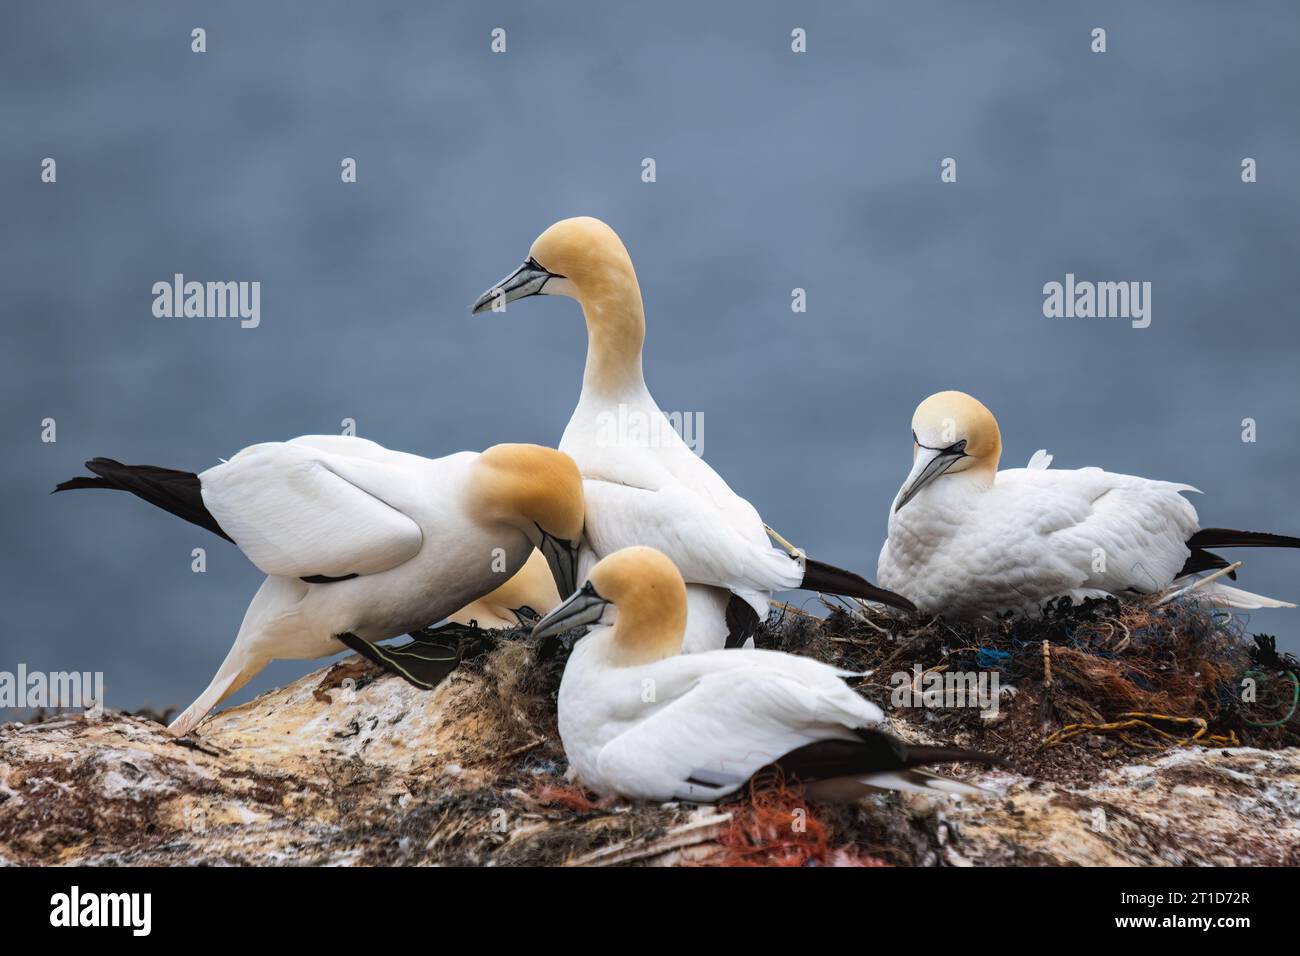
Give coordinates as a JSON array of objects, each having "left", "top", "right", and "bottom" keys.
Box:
[{"left": 894, "top": 392, "right": 1002, "bottom": 511}]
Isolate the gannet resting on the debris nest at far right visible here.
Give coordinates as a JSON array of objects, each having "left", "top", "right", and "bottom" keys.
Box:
[{"left": 876, "top": 392, "right": 1300, "bottom": 618}]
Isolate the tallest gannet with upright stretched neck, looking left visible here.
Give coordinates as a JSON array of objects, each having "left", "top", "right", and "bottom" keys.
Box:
[{"left": 472, "top": 216, "right": 914, "bottom": 652}]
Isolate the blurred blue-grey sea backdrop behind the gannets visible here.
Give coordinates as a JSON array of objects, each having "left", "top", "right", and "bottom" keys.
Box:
[{"left": 0, "top": 0, "right": 1300, "bottom": 708}]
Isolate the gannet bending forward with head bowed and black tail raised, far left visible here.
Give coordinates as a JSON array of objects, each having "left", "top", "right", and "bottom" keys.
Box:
[{"left": 55, "top": 436, "right": 582, "bottom": 736}]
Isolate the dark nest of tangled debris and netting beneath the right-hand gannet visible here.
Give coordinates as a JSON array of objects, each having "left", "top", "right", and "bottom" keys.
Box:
[{"left": 761, "top": 597, "right": 1300, "bottom": 782}]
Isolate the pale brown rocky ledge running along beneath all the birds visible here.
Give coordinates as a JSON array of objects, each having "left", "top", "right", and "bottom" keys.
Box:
[{"left": 0, "top": 644, "right": 1300, "bottom": 866}]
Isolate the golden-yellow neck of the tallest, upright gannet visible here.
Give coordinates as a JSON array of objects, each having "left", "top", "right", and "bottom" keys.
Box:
[{"left": 580, "top": 273, "right": 646, "bottom": 398}]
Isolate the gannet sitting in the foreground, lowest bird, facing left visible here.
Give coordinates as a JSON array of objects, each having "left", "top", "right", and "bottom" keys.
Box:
[{"left": 533, "top": 548, "right": 1001, "bottom": 803}]
